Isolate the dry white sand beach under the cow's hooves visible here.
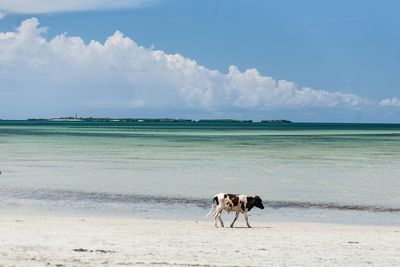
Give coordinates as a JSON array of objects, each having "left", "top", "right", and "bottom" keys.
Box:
[{"left": 0, "top": 215, "right": 400, "bottom": 267}]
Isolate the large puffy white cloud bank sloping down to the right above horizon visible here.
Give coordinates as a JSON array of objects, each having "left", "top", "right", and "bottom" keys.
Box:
[{"left": 0, "top": 18, "right": 399, "bottom": 120}]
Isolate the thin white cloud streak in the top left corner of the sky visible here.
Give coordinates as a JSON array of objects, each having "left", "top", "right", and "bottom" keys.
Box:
[{"left": 0, "top": 0, "right": 154, "bottom": 19}]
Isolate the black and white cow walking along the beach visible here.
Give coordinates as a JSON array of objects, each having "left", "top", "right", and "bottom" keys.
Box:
[{"left": 206, "top": 193, "right": 264, "bottom": 228}]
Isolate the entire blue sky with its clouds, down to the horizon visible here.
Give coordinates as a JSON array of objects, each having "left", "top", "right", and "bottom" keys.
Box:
[{"left": 0, "top": 0, "right": 400, "bottom": 122}]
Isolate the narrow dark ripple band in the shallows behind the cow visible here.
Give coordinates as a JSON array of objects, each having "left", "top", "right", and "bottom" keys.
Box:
[{"left": 0, "top": 188, "right": 400, "bottom": 213}]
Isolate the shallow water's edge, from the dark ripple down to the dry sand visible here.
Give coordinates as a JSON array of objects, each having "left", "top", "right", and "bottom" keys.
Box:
[{"left": 0, "top": 186, "right": 400, "bottom": 226}]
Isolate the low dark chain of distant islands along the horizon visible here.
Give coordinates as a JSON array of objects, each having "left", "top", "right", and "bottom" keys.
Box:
[{"left": 28, "top": 116, "right": 291, "bottom": 123}]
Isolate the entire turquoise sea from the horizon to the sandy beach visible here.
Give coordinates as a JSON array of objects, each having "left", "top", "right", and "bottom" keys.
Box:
[{"left": 0, "top": 120, "right": 400, "bottom": 224}]
